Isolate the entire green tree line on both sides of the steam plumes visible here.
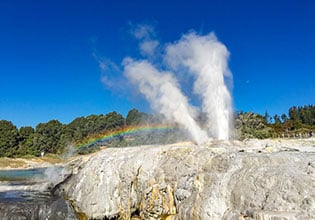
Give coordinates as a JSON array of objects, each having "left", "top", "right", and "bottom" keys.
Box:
[{"left": 0, "top": 105, "right": 315, "bottom": 157}]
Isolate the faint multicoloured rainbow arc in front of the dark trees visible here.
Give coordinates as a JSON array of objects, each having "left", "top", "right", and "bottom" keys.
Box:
[{"left": 77, "top": 124, "right": 175, "bottom": 148}]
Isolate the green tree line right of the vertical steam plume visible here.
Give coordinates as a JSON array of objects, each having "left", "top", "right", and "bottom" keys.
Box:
[{"left": 235, "top": 105, "right": 315, "bottom": 139}]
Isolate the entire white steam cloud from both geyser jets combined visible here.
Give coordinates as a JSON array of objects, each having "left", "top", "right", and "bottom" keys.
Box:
[{"left": 102, "top": 26, "right": 232, "bottom": 144}]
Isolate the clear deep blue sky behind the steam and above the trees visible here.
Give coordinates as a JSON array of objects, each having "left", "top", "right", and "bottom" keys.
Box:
[{"left": 0, "top": 0, "right": 315, "bottom": 127}]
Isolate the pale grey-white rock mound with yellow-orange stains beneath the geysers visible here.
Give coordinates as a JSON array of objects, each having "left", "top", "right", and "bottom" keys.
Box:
[{"left": 60, "top": 141, "right": 315, "bottom": 220}]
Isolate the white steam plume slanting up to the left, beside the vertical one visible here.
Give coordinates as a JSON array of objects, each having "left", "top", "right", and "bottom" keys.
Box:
[{"left": 123, "top": 58, "right": 208, "bottom": 144}]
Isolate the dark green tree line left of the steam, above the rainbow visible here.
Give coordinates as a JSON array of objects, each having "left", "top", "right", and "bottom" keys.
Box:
[{"left": 0, "top": 109, "right": 157, "bottom": 157}]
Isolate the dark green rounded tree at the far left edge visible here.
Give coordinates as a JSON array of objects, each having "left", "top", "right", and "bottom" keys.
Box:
[{"left": 0, "top": 120, "right": 19, "bottom": 157}]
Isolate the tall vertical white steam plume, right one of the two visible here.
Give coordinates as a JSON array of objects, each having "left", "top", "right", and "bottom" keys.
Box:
[{"left": 165, "top": 33, "right": 232, "bottom": 139}]
